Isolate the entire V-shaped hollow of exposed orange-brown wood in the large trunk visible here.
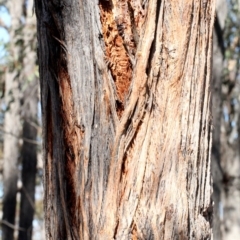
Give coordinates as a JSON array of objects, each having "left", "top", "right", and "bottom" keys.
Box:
[{"left": 99, "top": 0, "right": 145, "bottom": 117}]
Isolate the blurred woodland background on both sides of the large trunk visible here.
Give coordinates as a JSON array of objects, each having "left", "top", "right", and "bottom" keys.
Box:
[{"left": 0, "top": 0, "right": 240, "bottom": 240}]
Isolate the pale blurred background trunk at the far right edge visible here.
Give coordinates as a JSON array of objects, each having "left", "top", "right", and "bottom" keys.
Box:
[{"left": 221, "top": 77, "right": 240, "bottom": 240}]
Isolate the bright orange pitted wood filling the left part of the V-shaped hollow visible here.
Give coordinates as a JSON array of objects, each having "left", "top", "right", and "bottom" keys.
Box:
[{"left": 100, "top": 1, "right": 132, "bottom": 117}]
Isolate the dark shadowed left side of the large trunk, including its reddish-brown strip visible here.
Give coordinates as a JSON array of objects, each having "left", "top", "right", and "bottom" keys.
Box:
[{"left": 35, "top": 2, "right": 84, "bottom": 239}]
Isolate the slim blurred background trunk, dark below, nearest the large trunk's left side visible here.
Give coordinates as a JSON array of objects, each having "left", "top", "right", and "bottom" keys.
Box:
[{"left": 18, "top": 1, "right": 38, "bottom": 240}]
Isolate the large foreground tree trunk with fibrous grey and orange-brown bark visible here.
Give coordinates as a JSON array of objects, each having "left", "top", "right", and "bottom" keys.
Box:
[{"left": 35, "top": 0, "right": 215, "bottom": 240}]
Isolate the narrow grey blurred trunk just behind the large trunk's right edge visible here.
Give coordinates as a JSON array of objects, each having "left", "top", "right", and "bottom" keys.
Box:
[{"left": 212, "top": 0, "right": 227, "bottom": 240}]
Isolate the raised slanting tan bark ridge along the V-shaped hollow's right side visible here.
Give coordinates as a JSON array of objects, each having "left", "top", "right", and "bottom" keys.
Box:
[{"left": 99, "top": 1, "right": 156, "bottom": 236}]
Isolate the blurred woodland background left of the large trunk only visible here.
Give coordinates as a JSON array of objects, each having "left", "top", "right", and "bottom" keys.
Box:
[{"left": 0, "top": 0, "right": 45, "bottom": 240}]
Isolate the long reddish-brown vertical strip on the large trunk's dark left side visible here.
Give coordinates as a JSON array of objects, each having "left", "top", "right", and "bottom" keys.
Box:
[{"left": 58, "top": 58, "right": 84, "bottom": 236}]
